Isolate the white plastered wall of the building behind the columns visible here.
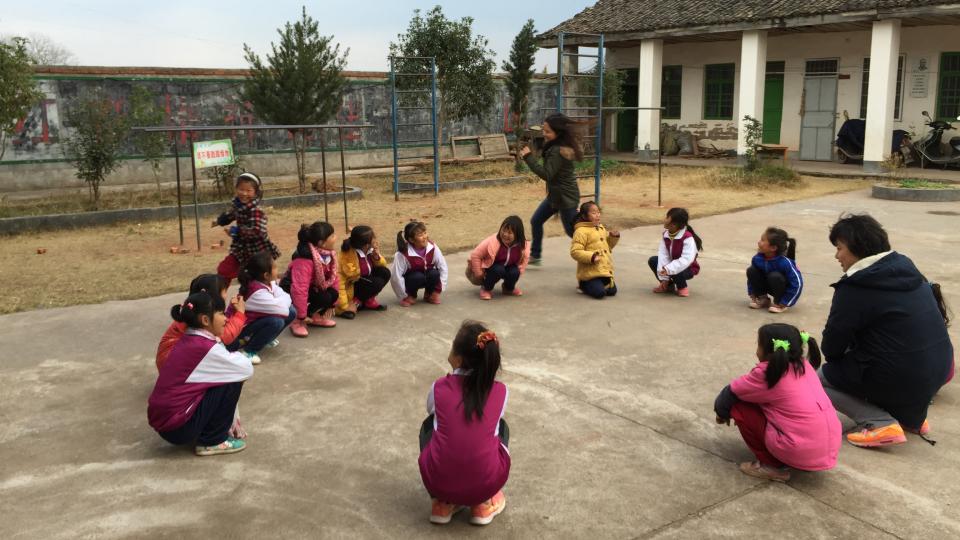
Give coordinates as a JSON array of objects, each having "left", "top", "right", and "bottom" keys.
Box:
[{"left": 607, "top": 26, "right": 960, "bottom": 151}]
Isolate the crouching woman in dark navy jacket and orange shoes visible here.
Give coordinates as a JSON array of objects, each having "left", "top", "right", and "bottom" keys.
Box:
[{"left": 819, "top": 215, "right": 953, "bottom": 447}]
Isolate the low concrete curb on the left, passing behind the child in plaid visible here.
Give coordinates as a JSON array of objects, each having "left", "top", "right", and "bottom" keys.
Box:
[{"left": 0, "top": 186, "right": 363, "bottom": 234}]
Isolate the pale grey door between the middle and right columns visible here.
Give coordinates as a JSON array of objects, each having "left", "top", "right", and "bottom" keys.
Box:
[{"left": 800, "top": 75, "right": 837, "bottom": 161}]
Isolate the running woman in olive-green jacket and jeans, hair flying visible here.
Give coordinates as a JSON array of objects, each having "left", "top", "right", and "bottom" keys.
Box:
[{"left": 520, "top": 113, "right": 583, "bottom": 265}]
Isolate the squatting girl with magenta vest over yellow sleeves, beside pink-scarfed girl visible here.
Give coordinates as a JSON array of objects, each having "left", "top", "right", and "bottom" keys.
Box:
[{"left": 337, "top": 225, "right": 390, "bottom": 319}]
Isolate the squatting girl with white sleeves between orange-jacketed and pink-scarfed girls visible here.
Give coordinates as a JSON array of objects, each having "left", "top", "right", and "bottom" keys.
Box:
[{"left": 230, "top": 252, "right": 297, "bottom": 364}]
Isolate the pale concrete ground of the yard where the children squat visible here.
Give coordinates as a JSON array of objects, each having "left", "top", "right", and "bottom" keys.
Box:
[{"left": 0, "top": 191, "right": 960, "bottom": 539}]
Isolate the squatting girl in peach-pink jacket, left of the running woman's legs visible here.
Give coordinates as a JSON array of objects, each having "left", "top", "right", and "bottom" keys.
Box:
[{"left": 467, "top": 216, "right": 530, "bottom": 300}]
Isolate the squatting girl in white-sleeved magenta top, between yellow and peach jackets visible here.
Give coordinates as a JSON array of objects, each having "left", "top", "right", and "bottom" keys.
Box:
[{"left": 390, "top": 221, "right": 447, "bottom": 307}]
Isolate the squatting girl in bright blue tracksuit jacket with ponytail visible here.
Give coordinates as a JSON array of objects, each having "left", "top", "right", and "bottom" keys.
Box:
[{"left": 747, "top": 227, "right": 803, "bottom": 313}]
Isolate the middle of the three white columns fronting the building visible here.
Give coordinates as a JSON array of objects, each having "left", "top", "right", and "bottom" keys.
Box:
[{"left": 737, "top": 30, "right": 767, "bottom": 156}]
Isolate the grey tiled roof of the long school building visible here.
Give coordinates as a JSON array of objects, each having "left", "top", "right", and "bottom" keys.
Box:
[{"left": 540, "top": 0, "right": 957, "bottom": 39}]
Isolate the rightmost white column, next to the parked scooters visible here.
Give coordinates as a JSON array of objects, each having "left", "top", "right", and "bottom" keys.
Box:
[{"left": 863, "top": 19, "right": 900, "bottom": 172}]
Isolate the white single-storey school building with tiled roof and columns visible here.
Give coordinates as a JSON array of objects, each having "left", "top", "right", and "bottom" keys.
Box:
[{"left": 539, "top": 0, "right": 960, "bottom": 171}]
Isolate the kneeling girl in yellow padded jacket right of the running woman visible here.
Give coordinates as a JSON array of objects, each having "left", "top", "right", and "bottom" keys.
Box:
[{"left": 570, "top": 201, "right": 620, "bottom": 300}]
